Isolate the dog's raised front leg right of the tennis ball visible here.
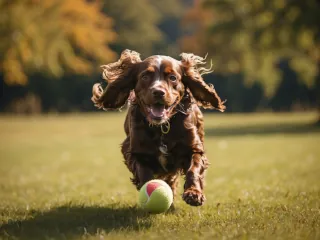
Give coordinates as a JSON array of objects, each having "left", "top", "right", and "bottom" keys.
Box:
[{"left": 182, "top": 153, "right": 208, "bottom": 206}]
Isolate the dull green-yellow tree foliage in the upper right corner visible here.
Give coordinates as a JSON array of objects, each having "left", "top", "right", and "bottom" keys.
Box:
[{"left": 184, "top": 0, "right": 320, "bottom": 96}]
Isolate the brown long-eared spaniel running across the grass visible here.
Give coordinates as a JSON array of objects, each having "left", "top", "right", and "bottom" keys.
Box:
[{"left": 92, "top": 50, "right": 225, "bottom": 206}]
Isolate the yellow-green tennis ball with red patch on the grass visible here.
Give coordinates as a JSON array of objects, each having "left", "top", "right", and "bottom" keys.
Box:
[{"left": 139, "top": 179, "right": 173, "bottom": 213}]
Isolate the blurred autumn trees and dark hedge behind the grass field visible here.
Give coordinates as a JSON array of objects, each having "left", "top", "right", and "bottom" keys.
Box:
[{"left": 0, "top": 0, "right": 320, "bottom": 120}]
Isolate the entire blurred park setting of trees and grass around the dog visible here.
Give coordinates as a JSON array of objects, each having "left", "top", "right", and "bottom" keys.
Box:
[{"left": 0, "top": 0, "right": 320, "bottom": 240}]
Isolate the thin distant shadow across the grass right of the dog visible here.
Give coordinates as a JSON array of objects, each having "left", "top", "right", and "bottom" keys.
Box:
[{"left": 206, "top": 123, "right": 320, "bottom": 136}]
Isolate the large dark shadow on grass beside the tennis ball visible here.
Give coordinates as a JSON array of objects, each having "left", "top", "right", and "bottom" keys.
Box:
[{"left": 0, "top": 206, "right": 151, "bottom": 239}]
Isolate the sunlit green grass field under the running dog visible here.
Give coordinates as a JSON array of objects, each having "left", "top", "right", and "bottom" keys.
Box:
[{"left": 0, "top": 113, "right": 320, "bottom": 239}]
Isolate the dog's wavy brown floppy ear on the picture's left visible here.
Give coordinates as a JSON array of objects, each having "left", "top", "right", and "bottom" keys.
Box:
[{"left": 91, "top": 49, "right": 141, "bottom": 109}]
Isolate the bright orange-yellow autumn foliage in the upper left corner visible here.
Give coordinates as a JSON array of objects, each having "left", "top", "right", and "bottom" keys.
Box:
[{"left": 0, "top": 0, "right": 115, "bottom": 85}]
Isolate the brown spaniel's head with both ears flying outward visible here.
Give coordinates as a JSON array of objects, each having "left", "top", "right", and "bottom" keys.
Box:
[{"left": 92, "top": 50, "right": 225, "bottom": 124}]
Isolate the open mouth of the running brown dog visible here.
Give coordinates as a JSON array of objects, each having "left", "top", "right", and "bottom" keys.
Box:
[{"left": 146, "top": 100, "right": 177, "bottom": 124}]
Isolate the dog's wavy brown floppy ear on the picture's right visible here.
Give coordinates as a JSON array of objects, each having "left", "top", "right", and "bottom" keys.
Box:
[{"left": 180, "top": 53, "right": 226, "bottom": 112}]
